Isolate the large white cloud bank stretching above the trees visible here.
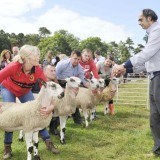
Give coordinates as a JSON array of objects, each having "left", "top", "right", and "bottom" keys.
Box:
[{"left": 0, "top": 0, "right": 132, "bottom": 42}]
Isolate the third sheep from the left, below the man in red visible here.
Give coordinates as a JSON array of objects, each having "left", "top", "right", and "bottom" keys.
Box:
[{"left": 76, "top": 79, "right": 99, "bottom": 127}]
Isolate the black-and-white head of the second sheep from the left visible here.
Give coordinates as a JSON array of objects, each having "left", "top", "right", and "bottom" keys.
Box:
[{"left": 65, "top": 77, "right": 81, "bottom": 94}]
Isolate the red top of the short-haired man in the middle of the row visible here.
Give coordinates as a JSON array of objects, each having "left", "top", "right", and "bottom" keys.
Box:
[{"left": 79, "top": 59, "right": 99, "bottom": 79}]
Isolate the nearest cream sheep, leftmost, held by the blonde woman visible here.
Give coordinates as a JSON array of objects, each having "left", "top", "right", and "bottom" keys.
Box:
[{"left": 0, "top": 82, "right": 63, "bottom": 160}]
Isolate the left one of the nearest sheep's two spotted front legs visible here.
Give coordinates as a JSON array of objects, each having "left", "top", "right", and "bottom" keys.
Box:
[{"left": 25, "top": 131, "right": 33, "bottom": 160}]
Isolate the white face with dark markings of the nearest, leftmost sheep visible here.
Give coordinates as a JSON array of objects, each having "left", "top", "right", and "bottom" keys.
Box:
[{"left": 46, "top": 82, "right": 63, "bottom": 97}]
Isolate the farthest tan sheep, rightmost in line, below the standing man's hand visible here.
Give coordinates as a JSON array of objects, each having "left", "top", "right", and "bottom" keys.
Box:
[{"left": 100, "top": 79, "right": 117, "bottom": 115}]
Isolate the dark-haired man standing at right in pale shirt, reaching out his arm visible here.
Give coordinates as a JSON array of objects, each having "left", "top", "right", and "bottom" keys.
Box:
[{"left": 113, "top": 9, "right": 160, "bottom": 156}]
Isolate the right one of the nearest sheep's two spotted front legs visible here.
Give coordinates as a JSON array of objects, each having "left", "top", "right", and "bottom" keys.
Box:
[{"left": 33, "top": 131, "right": 40, "bottom": 160}]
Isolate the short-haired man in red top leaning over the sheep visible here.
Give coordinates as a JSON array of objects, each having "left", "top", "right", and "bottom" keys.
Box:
[{"left": 79, "top": 49, "right": 99, "bottom": 79}]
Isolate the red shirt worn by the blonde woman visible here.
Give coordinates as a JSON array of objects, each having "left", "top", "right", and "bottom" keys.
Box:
[{"left": 0, "top": 62, "right": 46, "bottom": 97}]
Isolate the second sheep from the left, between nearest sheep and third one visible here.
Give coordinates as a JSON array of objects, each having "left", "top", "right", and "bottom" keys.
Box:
[{"left": 53, "top": 77, "right": 81, "bottom": 144}]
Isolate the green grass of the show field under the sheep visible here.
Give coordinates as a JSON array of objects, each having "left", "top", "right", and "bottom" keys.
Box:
[{"left": 0, "top": 106, "right": 156, "bottom": 160}]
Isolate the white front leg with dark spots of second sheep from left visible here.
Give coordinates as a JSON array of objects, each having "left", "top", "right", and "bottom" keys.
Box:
[{"left": 59, "top": 116, "right": 67, "bottom": 144}]
